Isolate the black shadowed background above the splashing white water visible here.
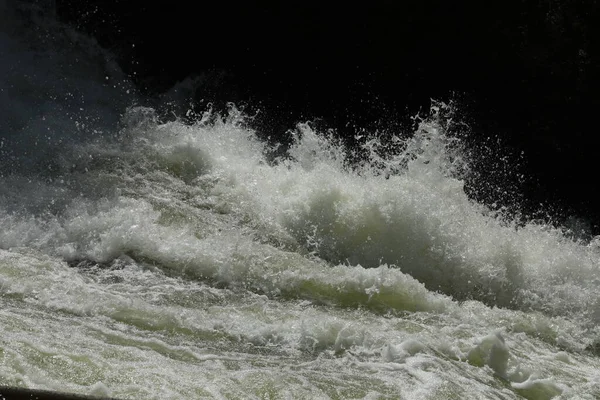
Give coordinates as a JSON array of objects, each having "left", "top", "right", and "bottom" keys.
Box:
[{"left": 56, "top": 0, "right": 600, "bottom": 234}]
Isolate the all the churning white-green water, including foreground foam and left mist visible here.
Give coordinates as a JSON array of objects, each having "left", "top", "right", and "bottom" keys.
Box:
[{"left": 0, "top": 3, "right": 600, "bottom": 399}]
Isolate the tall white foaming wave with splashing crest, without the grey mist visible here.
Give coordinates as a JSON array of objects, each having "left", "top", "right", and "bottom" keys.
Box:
[{"left": 0, "top": 100, "right": 599, "bottom": 320}]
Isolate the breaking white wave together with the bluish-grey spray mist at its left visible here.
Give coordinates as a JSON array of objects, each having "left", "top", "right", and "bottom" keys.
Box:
[{"left": 0, "top": 0, "right": 600, "bottom": 328}]
